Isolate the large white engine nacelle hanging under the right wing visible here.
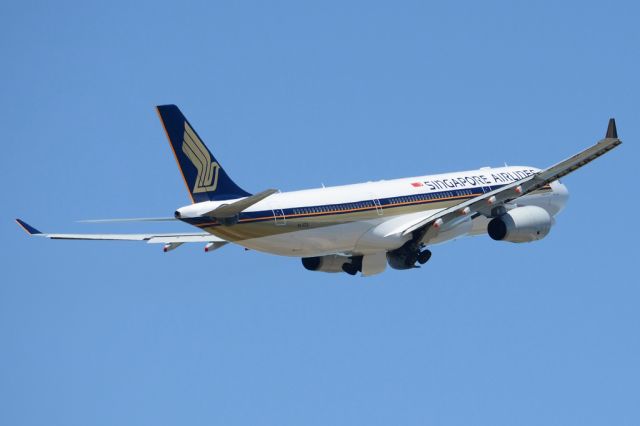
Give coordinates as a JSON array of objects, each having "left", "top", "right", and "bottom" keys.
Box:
[{"left": 487, "top": 206, "right": 553, "bottom": 243}]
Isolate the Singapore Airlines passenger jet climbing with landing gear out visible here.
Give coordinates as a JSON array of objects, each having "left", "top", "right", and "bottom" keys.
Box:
[{"left": 16, "top": 105, "right": 622, "bottom": 276}]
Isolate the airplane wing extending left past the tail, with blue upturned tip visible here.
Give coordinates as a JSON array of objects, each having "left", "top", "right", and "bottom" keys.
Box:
[{"left": 16, "top": 219, "right": 227, "bottom": 251}]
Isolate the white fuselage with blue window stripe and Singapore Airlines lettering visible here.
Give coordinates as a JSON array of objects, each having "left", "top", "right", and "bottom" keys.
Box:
[{"left": 178, "top": 167, "right": 568, "bottom": 257}]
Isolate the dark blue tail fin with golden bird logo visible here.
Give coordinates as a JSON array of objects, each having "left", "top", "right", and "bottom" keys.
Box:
[{"left": 156, "top": 105, "right": 251, "bottom": 203}]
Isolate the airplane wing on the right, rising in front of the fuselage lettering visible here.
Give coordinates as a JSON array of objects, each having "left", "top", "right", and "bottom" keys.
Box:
[{"left": 402, "top": 118, "right": 622, "bottom": 240}]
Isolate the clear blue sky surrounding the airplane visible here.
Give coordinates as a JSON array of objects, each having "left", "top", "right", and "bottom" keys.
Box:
[{"left": 0, "top": 1, "right": 640, "bottom": 426}]
